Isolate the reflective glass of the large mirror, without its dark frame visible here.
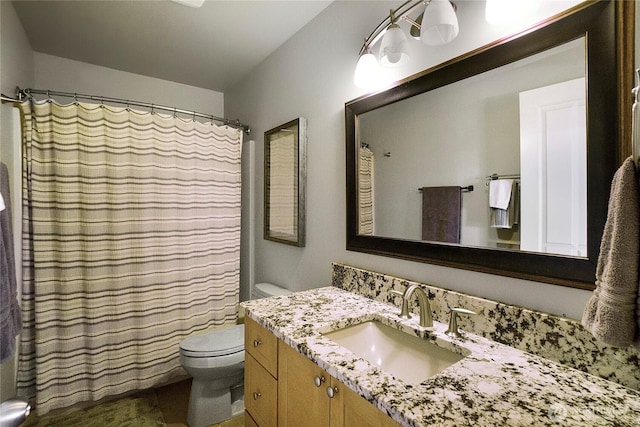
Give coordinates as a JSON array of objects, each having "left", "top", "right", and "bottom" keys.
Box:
[{"left": 358, "top": 37, "right": 587, "bottom": 256}]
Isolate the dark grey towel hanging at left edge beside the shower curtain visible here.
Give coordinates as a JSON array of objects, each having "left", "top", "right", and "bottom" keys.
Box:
[{"left": 0, "top": 163, "right": 22, "bottom": 363}]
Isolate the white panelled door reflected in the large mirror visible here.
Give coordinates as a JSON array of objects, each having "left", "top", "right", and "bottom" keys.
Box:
[{"left": 520, "top": 78, "right": 587, "bottom": 256}]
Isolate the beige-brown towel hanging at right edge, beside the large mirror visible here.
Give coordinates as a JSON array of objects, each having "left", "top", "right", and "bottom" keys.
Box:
[{"left": 582, "top": 157, "right": 640, "bottom": 347}]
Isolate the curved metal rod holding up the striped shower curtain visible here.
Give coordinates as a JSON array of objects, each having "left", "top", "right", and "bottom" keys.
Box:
[{"left": 13, "top": 87, "right": 251, "bottom": 133}]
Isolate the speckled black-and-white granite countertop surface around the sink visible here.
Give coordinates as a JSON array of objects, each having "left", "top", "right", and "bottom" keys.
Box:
[{"left": 242, "top": 287, "right": 640, "bottom": 427}]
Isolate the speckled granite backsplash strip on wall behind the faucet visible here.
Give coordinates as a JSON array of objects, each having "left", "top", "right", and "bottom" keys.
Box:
[{"left": 331, "top": 263, "right": 640, "bottom": 391}]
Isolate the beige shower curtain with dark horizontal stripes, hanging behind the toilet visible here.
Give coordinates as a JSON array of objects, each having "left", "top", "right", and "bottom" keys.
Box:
[{"left": 18, "top": 101, "right": 242, "bottom": 414}]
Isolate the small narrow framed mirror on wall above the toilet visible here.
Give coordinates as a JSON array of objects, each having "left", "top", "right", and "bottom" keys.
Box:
[{"left": 264, "top": 117, "right": 307, "bottom": 246}]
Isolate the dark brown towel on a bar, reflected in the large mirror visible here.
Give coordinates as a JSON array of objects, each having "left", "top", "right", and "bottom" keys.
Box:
[{"left": 421, "top": 186, "right": 462, "bottom": 243}]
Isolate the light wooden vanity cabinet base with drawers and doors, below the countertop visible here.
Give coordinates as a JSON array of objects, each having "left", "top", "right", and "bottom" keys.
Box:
[{"left": 245, "top": 318, "right": 399, "bottom": 427}]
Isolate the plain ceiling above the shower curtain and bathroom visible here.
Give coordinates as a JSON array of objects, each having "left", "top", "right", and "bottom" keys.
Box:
[{"left": 13, "top": 0, "right": 331, "bottom": 92}]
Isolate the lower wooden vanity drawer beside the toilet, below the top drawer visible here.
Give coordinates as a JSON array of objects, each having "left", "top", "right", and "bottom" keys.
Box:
[{"left": 244, "top": 354, "right": 278, "bottom": 427}]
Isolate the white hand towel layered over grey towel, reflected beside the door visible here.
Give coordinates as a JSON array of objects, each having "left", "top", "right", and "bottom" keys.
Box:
[{"left": 489, "top": 179, "right": 520, "bottom": 228}]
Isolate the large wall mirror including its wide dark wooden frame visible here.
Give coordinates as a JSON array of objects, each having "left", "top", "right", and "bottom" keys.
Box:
[{"left": 345, "top": 1, "right": 633, "bottom": 289}]
